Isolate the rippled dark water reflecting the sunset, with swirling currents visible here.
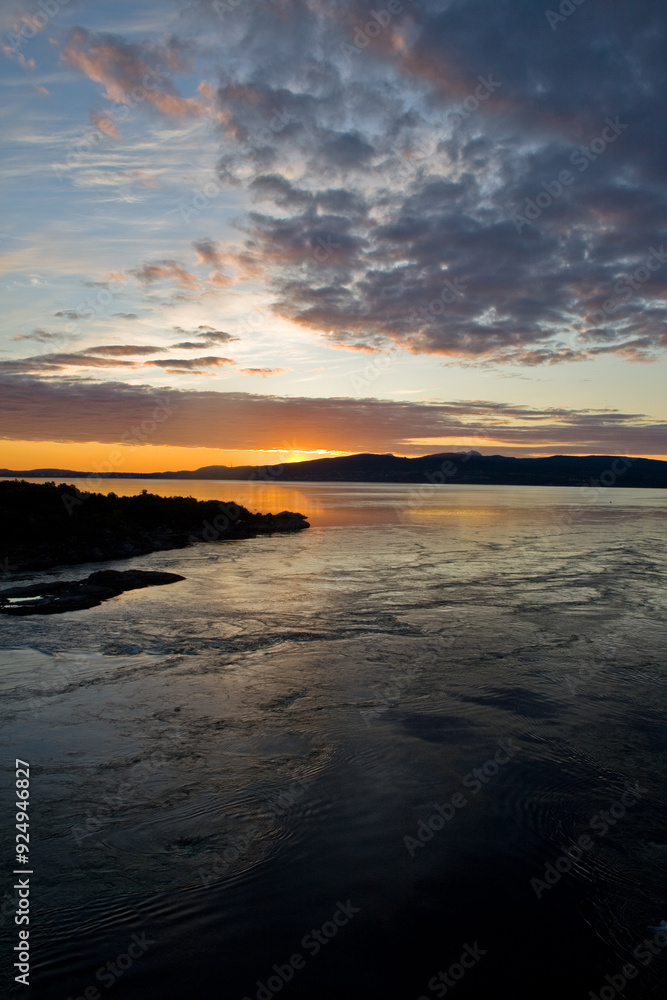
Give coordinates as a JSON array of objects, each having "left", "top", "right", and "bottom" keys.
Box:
[{"left": 0, "top": 480, "right": 667, "bottom": 1000}]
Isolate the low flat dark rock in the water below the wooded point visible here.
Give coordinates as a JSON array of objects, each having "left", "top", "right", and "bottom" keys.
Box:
[{"left": 0, "top": 569, "right": 185, "bottom": 615}]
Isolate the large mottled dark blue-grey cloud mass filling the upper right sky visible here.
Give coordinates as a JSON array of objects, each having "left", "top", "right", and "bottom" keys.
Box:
[{"left": 196, "top": 0, "right": 667, "bottom": 365}]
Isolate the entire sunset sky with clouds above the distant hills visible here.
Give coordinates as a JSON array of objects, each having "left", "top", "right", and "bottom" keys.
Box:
[{"left": 0, "top": 0, "right": 667, "bottom": 472}]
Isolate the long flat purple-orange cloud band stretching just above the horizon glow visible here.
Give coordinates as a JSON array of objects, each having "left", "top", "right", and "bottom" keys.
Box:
[{"left": 0, "top": 374, "right": 667, "bottom": 455}]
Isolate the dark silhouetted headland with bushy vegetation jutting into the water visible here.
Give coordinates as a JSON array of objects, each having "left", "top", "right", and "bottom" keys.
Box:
[{"left": 0, "top": 480, "right": 308, "bottom": 574}]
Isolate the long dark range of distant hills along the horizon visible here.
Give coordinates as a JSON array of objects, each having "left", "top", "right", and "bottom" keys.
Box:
[{"left": 0, "top": 451, "right": 667, "bottom": 490}]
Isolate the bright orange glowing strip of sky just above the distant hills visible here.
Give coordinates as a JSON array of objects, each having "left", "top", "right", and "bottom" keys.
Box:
[{"left": 0, "top": 438, "right": 667, "bottom": 474}]
